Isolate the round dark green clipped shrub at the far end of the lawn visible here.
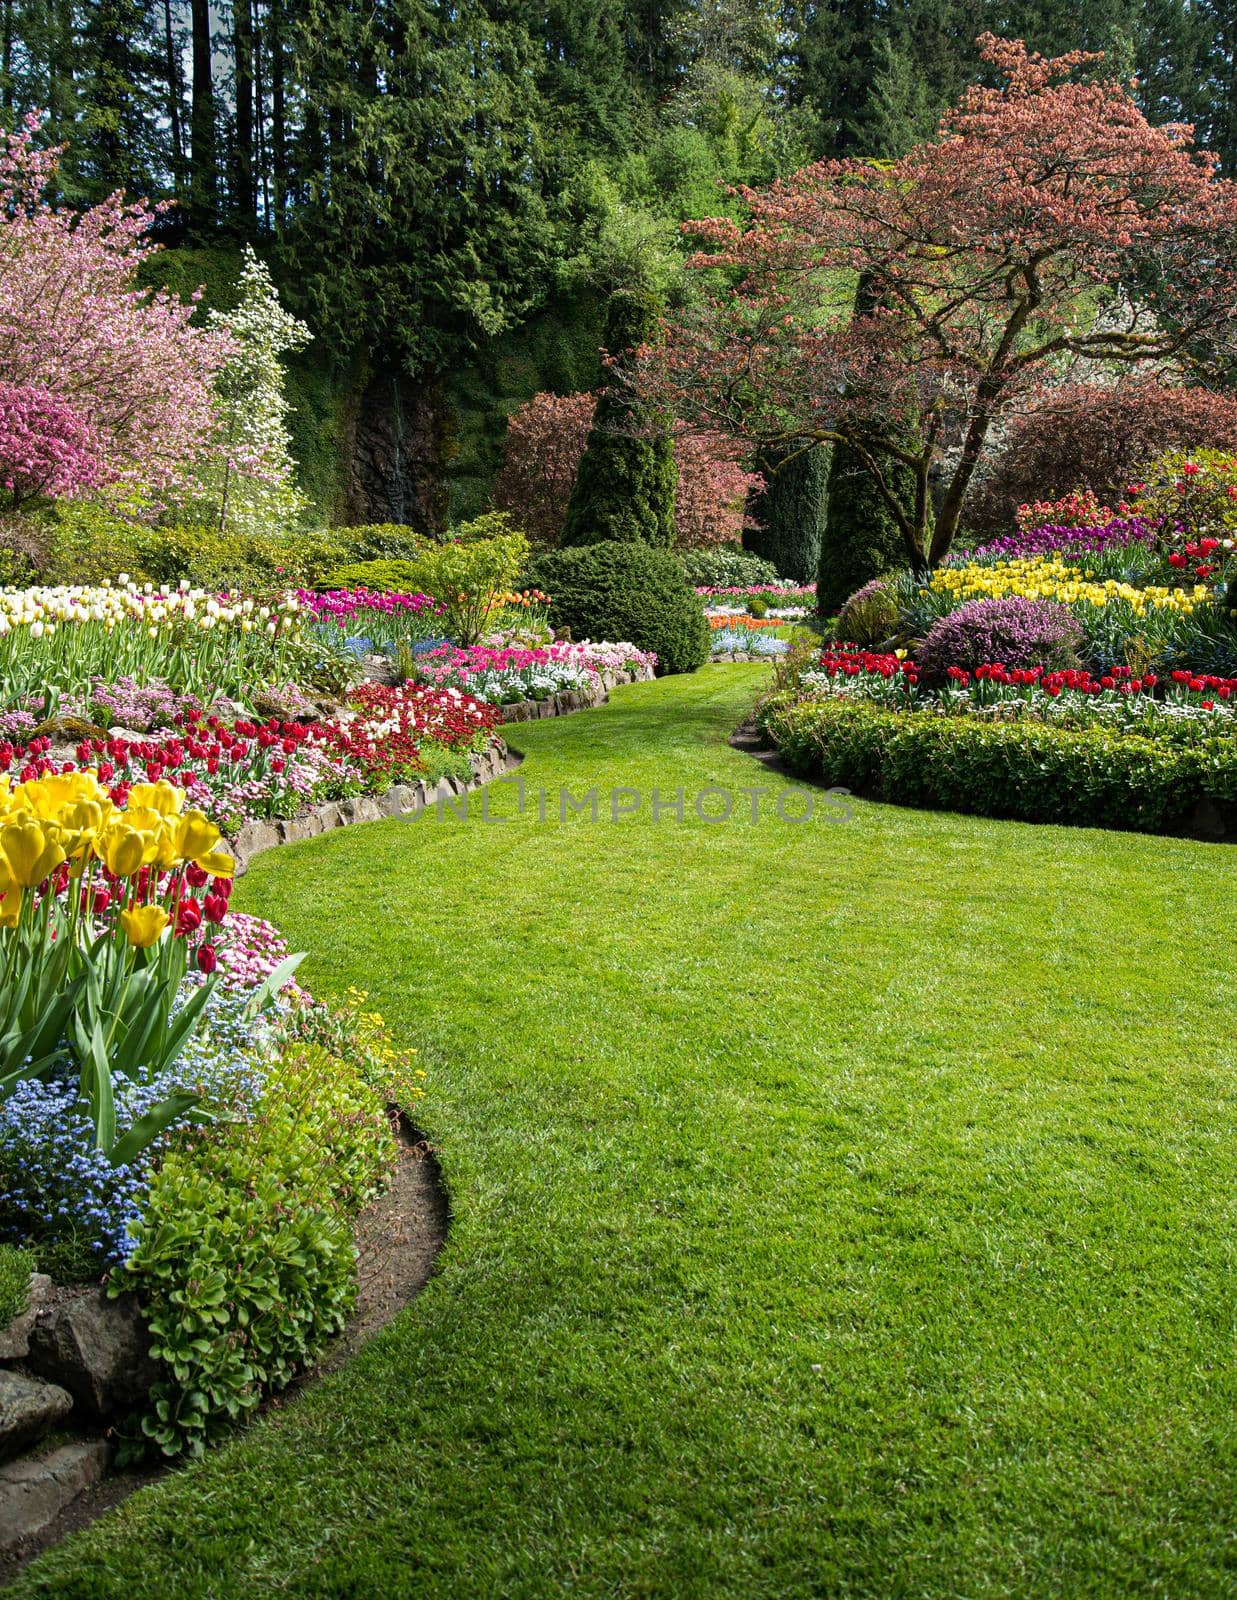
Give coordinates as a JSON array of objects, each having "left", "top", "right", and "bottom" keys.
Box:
[{"left": 530, "top": 539, "right": 709, "bottom": 674}]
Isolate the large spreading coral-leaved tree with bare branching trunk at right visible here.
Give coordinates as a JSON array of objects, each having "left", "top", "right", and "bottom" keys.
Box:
[{"left": 639, "top": 34, "right": 1237, "bottom": 571}]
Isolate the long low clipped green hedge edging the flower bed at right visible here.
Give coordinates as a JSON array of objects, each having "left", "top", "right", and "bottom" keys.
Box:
[{"left": 760, "top": 698, "right": 1237, "bottom": 834}]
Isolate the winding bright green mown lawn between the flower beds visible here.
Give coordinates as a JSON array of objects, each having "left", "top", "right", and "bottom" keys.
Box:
[{"left": 16, "top": 667, "right": 1237, "bottom": 1600}]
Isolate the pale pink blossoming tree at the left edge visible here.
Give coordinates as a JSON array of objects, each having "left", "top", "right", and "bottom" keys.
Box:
[{"left": 0, "top": 117, "right": 230, "bottom": 491}]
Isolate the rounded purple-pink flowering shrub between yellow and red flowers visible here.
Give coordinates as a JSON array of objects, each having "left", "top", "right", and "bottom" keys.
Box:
[{"left": 915, "top": 595, "right": 1083, "bottom": 683}]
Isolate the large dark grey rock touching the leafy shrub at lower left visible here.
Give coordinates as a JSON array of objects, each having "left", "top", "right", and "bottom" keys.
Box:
[{"left": 29, "top": 1290, "right": 158, "bottom": 1419}]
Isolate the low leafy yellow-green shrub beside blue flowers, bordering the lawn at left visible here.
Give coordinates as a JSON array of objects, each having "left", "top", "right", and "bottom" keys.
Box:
[{"left": 109, "top": 1043, "right": 395, "bottom": 1456}]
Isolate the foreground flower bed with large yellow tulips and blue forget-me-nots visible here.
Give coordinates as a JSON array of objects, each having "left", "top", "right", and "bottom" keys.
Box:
[{"left": 0, "top": 771, "right": 421, "bottom": 1454}]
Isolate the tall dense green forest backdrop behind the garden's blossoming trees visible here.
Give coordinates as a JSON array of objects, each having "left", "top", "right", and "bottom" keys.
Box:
[{"left": 9, "top": 0, "right": 1237, "bottom": 517}]
